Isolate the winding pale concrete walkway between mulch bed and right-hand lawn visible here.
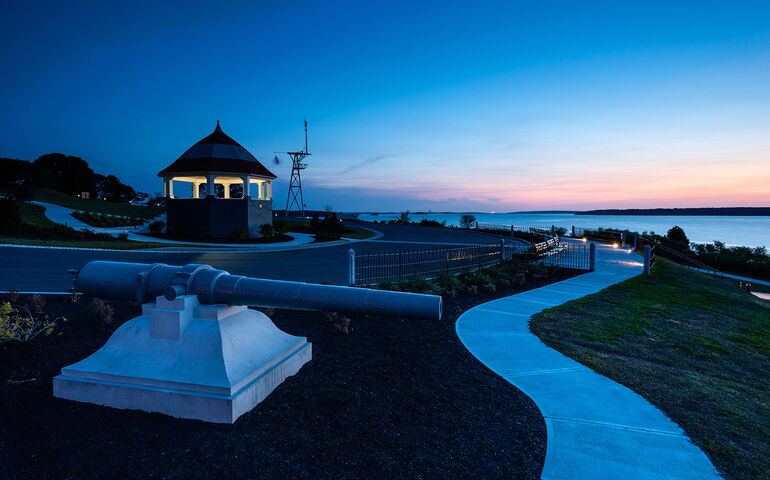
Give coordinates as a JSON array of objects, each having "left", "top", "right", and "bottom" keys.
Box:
[{"left": 456, "top": 245, "right": 721, "bottom": 480}]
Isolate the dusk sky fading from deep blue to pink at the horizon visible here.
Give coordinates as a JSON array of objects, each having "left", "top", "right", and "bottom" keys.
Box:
[{"left": 0, "top": 0, "right": 770, "bottom": 211}]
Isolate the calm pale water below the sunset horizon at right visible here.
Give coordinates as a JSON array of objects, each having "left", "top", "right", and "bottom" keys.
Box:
[{"left": 359, "top": 213, "right": 770, "bottom": 248}]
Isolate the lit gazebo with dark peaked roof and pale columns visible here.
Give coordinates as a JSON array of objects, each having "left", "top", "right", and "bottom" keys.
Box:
[{"left": 158, "top": 120, "right": 276, "bottom": 238}]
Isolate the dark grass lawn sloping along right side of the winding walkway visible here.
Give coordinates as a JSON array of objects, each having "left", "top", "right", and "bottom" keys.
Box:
[{"left": 531, "top": 259, "right": 770, "bottom": 479}]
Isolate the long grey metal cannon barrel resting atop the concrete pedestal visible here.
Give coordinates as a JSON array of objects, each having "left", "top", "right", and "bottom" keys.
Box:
[{"left": 73, "top": 261, "right": 441, "bottom": 320}]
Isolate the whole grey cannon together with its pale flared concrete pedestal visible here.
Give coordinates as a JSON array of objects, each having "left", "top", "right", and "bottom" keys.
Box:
[{"left": 53, "top": 261, "right": 441, "bottom": 423}]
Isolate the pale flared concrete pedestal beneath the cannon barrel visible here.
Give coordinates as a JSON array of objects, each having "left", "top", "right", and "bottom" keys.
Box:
[{"left": 53, "top": 295, "right": 312, "bottom": 423}]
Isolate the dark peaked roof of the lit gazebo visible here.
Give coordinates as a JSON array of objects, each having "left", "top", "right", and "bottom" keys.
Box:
[{"left": 158, "top": 120, "right": 276, "bottom": 178}]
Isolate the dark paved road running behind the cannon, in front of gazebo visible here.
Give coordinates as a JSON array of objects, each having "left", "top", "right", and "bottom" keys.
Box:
[{"left": 0, "top": 225, "right": 516, "bottom": 292}]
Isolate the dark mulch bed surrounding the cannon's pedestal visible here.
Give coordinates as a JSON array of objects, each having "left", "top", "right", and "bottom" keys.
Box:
[{"left": 0, "top": 270, "right": 575, "bottom": 479}]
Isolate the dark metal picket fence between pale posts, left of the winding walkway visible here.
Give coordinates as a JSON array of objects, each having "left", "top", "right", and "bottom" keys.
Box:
[{"left": 349, "top": 239, "right": 591, "bottom": 285}]
